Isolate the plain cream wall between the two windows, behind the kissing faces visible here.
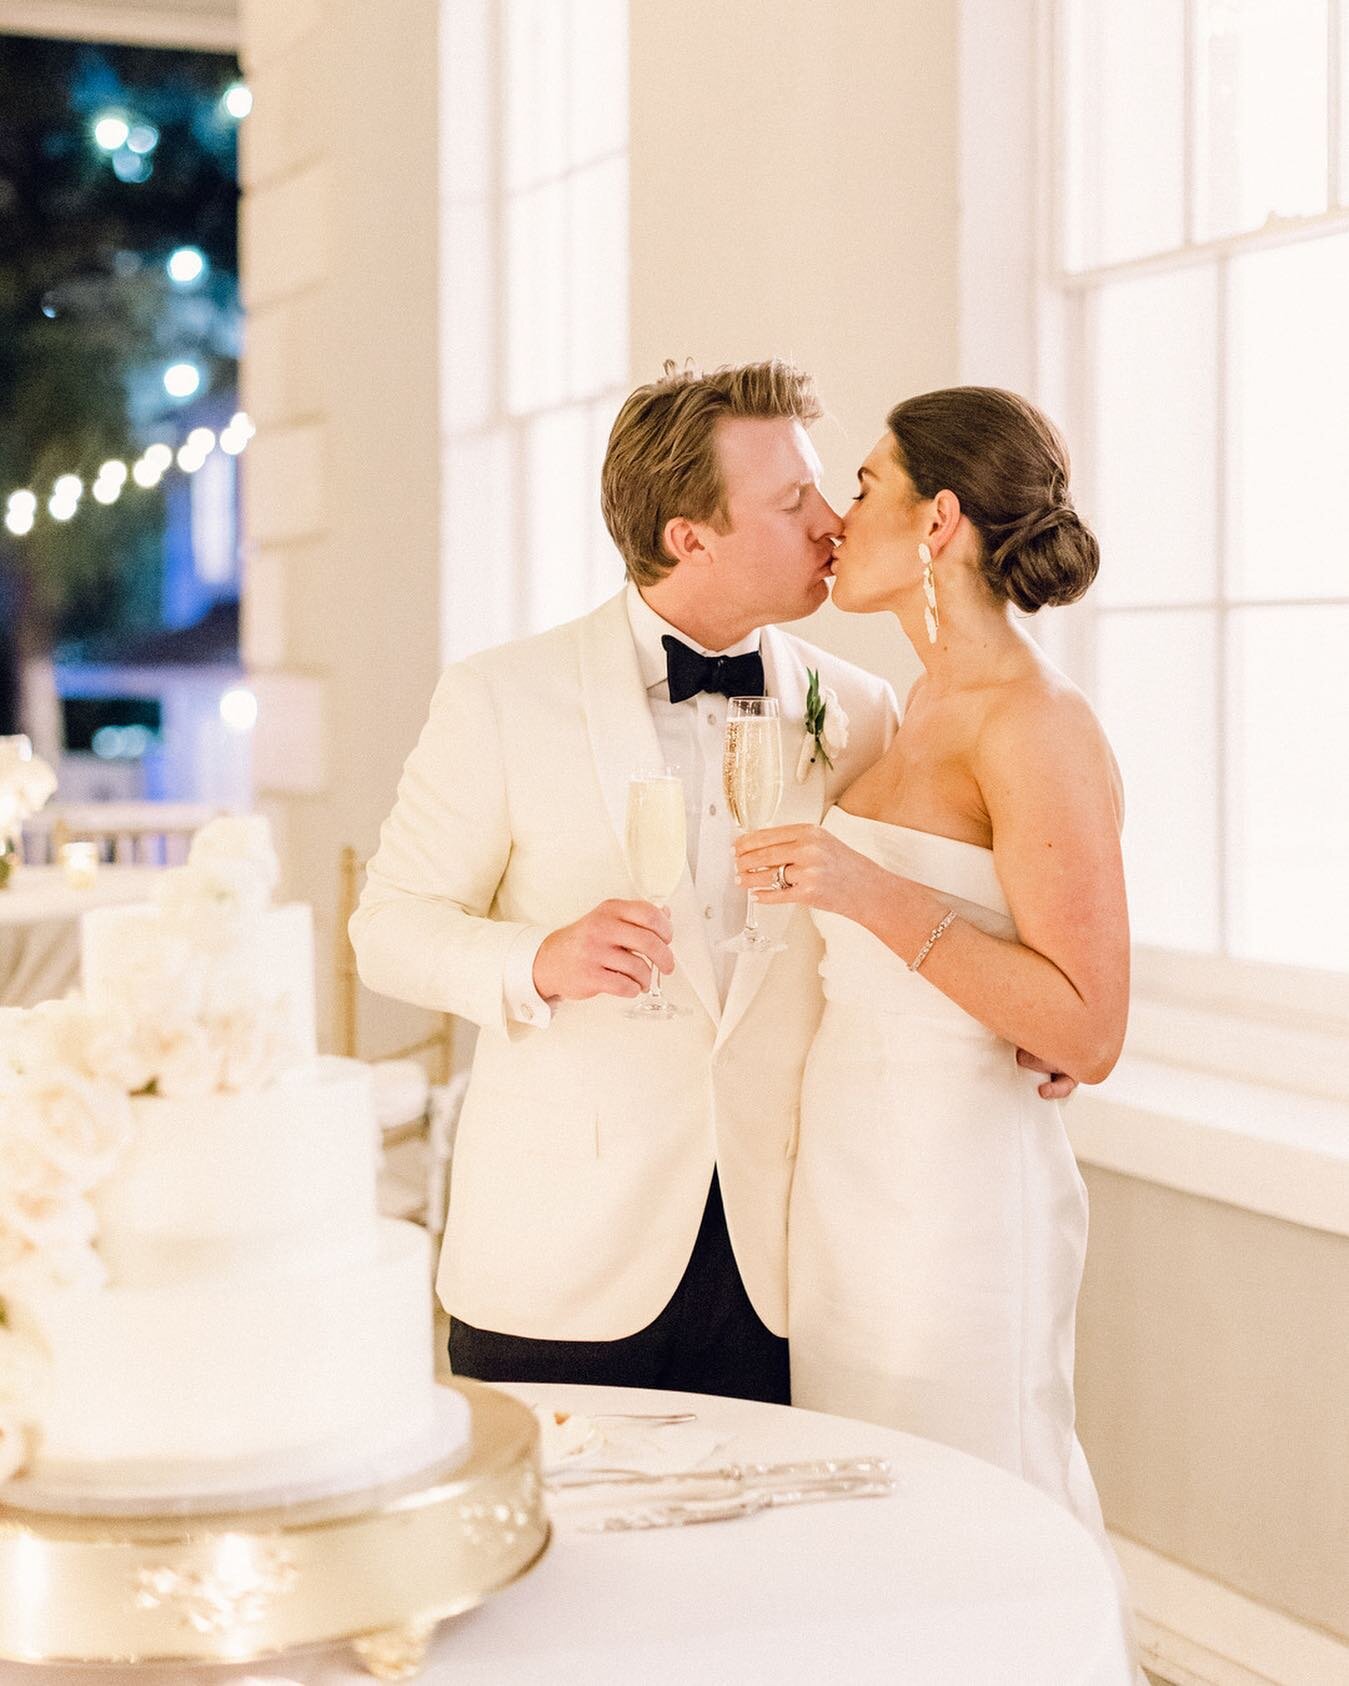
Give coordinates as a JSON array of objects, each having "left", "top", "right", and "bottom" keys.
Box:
[{"left": 629, "top": 0, "right": 958, "bottom": 695}]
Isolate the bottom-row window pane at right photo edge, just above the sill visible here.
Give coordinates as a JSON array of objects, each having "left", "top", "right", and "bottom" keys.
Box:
[{"left": 1228, "top": 609, "right": 1349, "bottom": 971}]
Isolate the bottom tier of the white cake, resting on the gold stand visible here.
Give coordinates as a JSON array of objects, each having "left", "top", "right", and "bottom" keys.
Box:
[{"left": 24, "top": 1219, "right": 432, "bottom": 1492}]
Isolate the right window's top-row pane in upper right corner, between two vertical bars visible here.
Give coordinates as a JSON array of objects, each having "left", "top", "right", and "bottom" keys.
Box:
[{"left": 1194, "top": 0, "right": 1329, "bottom": 239}]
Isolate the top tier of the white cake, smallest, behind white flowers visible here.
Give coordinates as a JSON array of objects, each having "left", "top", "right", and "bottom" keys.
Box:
[{"left": 79, "top": 902, "right": 317, "bottom": 1060}]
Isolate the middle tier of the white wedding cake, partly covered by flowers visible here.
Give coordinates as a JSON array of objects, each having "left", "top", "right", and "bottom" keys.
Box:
[{"left": 94, "top": 1057, "right": 378, "bottom": 1288}]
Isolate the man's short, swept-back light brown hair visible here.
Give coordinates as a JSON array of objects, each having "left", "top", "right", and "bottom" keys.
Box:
[{"left": 600, "top": 357, "right": 823, "bottom": 585}]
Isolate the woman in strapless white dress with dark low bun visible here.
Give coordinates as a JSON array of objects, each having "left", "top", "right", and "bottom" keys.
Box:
[{"left": 737, "top": 386, "right": 1128, "bottom": 1578}]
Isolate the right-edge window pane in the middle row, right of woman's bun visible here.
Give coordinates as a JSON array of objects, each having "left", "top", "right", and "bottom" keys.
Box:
[{"left": 1228, "top": 234, "right": 1349, "bottom": 599}]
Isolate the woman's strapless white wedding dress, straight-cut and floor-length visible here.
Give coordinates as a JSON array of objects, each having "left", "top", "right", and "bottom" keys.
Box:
[{"left": 787, "top": 808, "right": 1139, "bottom": 1652}]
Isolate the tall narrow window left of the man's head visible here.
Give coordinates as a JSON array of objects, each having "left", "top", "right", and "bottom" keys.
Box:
[{"left": 442, "top": 0, "right": 627, "bottom": 661}]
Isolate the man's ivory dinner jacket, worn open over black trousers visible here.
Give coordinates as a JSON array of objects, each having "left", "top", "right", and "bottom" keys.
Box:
[{"left": 351, "top": 592, "right": 897, "bottom": 1340}]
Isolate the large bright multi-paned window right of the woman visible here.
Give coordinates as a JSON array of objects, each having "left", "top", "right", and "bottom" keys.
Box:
[{"left": 1052, "top": 0, "right": 1349, "bottom": 971}]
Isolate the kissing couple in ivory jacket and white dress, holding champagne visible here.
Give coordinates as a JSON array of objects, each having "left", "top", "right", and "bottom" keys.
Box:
[{"left": 351, "top": 361, "right": 1128, "bottom": 1638}]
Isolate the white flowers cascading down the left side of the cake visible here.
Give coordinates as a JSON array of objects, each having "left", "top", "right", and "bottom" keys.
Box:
[{"left": 0, "top": 821, "right": 297, "bottom": 1482}]
